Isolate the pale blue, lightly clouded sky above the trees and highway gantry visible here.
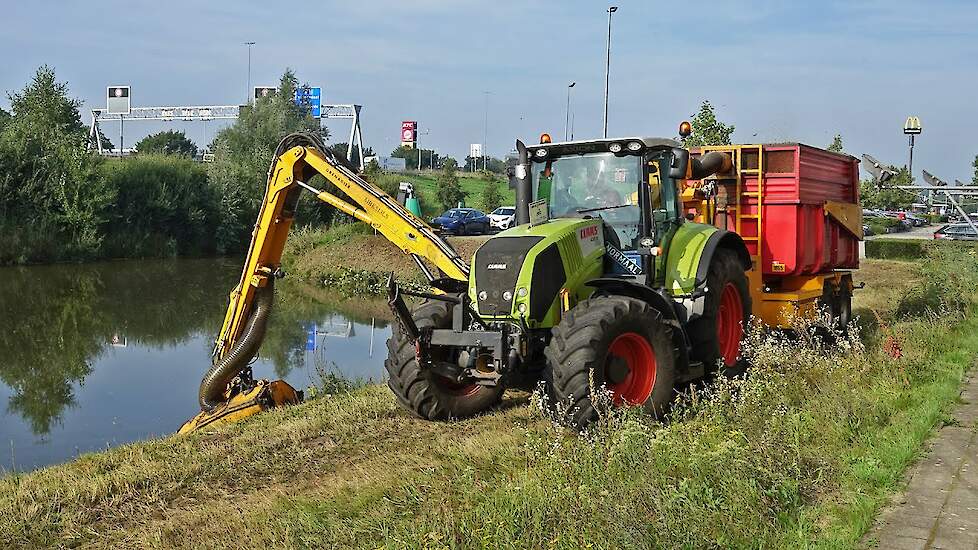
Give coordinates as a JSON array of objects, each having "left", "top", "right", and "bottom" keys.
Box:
[{"left": 0, "top": 0, "right": 978, "bottom": 181}]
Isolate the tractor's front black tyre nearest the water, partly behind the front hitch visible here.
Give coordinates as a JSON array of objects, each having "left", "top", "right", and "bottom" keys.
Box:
[{"left": 384, "top": 300, "right": 505, "bottom": 420}]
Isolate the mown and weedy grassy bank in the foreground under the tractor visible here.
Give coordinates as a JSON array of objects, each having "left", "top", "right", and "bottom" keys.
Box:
[{"left": 0, "top": 252, "right": 978, "bottom": 548}]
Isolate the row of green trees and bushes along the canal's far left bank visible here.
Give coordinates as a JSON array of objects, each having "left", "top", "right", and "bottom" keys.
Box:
[{"left": 0, "top": 66, "right": 336, "bottom": 265}]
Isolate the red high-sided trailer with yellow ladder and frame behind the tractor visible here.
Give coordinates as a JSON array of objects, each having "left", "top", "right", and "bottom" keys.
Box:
[{"left": 683, "top": 143, "right": 863, "bottom": 327}]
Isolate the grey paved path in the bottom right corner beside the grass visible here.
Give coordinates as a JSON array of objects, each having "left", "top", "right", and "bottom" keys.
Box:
[{"left": 873, "top": 373, "right": 978, "bottom": 550}]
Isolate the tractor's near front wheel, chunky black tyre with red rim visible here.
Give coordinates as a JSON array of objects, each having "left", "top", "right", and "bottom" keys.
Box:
[{"left": 544, "top": 296, "right": 676, "bottom": 430}]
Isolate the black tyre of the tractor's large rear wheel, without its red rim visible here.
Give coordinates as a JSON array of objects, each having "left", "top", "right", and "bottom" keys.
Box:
[{"left": 687, "top": 248, "right": 752, "bottom": 376}]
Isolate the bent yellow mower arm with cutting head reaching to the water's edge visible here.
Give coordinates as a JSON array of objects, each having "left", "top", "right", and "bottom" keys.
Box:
[{"left": 180, "top": 134, "right": 469, "bottom": 433}]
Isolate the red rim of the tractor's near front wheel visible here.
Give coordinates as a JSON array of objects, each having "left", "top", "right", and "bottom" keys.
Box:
[{"left": 605, "top": 332, "right": 656, "bottom": 405}]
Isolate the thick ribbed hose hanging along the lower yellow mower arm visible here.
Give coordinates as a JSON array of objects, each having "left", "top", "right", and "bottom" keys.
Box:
[{"left": 199, "top": 277, "right": 275, "bottom": 412}]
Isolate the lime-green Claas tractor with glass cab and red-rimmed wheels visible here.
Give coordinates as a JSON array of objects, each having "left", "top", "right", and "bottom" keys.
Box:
[{"left": 385, "top": 138, "right": 751, "bottom": 429}]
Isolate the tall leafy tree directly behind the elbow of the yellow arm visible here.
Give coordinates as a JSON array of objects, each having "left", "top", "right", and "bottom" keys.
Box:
[{"left": 208, "top": 69, "right": 331, "bottom": 252}]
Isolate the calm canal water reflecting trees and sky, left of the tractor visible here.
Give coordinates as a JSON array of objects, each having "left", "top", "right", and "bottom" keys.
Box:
[{"left": 0, "top": 259, "right": 390, "bottom": 475}]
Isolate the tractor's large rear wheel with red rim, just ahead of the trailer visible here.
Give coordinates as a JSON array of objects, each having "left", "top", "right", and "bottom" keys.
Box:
[{"left": 687, "top": 248, "right": 751, "bottom": 376}]
